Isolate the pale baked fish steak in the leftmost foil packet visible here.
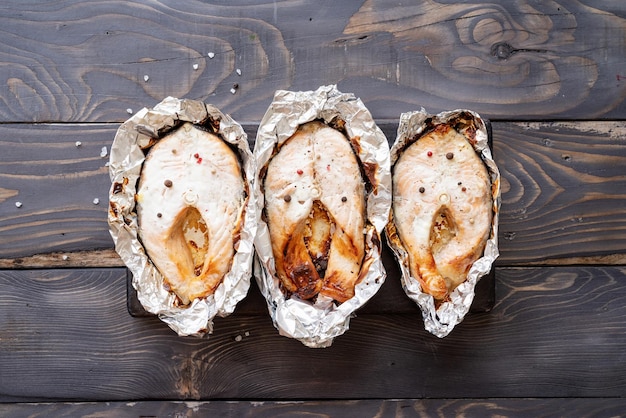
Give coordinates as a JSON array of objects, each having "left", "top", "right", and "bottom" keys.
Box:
[{"left": 136, "top": 123, "right": 246, "bottom": 305}]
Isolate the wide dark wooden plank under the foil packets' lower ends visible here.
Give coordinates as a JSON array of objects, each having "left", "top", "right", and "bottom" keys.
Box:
[{"left": 0, "top": 267, "right": 626, "bottom": 402}]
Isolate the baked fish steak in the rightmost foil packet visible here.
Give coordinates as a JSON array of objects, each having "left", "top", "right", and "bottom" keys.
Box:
[{"left": 392, "top": 124, "right": 493, "bottom": 302}]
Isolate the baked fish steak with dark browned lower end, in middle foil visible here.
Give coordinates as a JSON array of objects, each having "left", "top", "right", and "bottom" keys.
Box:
[{"left": 263, "top": 121, "right": 365, "bottom": 302}]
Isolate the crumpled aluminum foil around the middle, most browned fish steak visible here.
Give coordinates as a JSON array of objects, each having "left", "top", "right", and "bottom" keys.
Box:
[{"left": 254, "top": 85, "right": 391, "bottom": 348}]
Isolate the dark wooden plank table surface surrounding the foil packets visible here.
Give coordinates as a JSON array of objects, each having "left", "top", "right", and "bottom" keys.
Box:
[{"left": 0, "top": 0, "right": 626, "bottom": 417}]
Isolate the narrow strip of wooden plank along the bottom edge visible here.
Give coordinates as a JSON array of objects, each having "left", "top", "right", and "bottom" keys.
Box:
[{"left": 0, "top": 398, "right": 626, "bottom": 418}]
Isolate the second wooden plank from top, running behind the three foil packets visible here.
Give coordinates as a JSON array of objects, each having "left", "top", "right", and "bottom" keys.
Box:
[{"left": 0, "top": 122, "right": 626, "bottom": 268}]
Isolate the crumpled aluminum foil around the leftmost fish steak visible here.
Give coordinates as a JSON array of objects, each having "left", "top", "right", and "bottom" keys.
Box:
[{"left": 108, "top": 97, "right": 257, "bottom": 336}]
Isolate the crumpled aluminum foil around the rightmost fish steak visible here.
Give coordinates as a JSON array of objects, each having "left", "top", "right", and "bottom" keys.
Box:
[{"left": 386, "top": 109, "right": 500, "bottom": 338}]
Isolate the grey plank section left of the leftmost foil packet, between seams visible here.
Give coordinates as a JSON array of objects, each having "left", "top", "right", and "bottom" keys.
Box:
[{"left": 0, "top": 124, "right": 117, "bottom": 258}]
